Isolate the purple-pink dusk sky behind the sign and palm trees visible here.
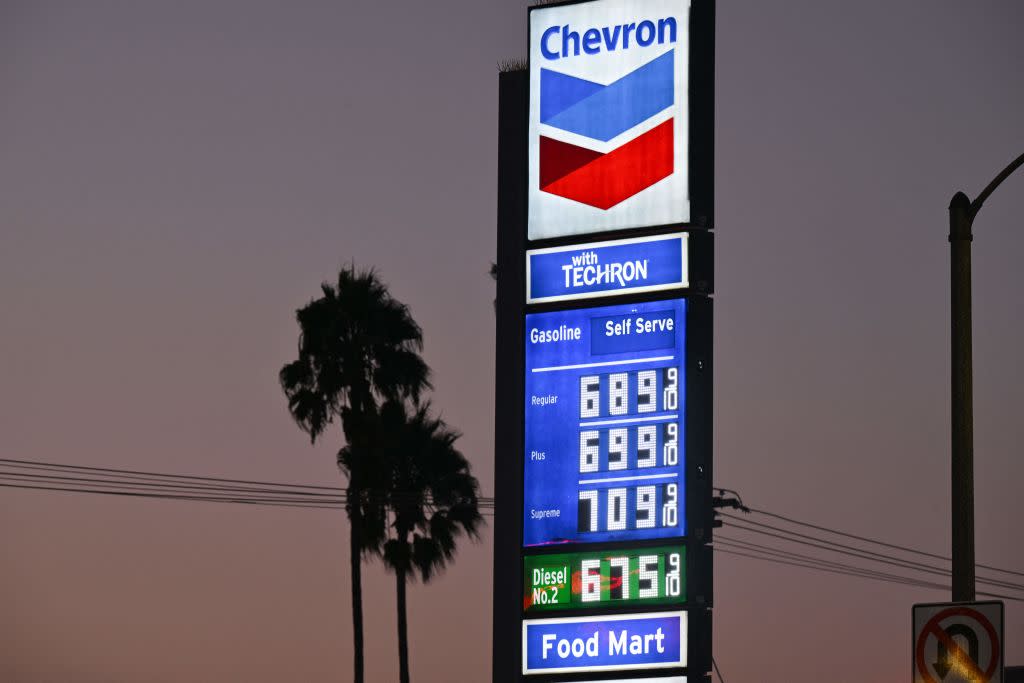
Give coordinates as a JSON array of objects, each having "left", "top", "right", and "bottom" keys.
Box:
[{"left": 0, "top": 0, "right": 1024, "bottom": 683}]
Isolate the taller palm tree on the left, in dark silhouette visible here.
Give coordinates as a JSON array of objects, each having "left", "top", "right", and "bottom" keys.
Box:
[{"left": 279, "top": 265, "right": 430, "bottom": 683}]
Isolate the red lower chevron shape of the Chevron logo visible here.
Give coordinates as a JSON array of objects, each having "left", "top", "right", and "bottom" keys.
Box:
[{"left": 540, "top": 119, "right": 675, "bottom": 210}]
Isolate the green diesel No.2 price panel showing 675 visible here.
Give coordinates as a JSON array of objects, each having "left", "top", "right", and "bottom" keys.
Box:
[{"left": 523, "top": 546, "right": 686, "bottom": 613}]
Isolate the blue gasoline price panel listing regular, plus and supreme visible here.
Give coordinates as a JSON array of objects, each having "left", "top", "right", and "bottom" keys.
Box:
[{"left": 523, "top": 299, "right": 686, "bottom": 546}]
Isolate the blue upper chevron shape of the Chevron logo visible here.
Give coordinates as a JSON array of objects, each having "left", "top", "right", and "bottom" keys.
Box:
[{"left": 541, "top": 50, "right": 676, "bottom": 142}]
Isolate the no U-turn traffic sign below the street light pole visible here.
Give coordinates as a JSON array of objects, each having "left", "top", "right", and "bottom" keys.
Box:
[{"left": 912, "top": 602, "right": 1004, "bottom": 683}]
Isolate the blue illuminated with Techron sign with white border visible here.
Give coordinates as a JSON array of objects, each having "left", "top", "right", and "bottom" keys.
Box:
[{"left": 526, "top": 232, "right": 689, "bottom": 303}]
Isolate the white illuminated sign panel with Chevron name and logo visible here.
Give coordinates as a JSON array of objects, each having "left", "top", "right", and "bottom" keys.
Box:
[{"left": 527, "top": 0, "right": 690, "bottom": 240}]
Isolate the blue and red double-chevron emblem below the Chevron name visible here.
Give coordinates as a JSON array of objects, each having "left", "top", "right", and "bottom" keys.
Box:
[{"left": 540, "top": 50, "right": 675, "bottom": 210}]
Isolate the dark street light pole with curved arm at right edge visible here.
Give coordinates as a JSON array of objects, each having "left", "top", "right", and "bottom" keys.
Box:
[{"left": 949, "top": 150, "right": 1024, "bottom": 602}]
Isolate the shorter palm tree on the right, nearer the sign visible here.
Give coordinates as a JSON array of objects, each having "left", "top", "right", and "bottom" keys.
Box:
[{"left": 352, "top": 401, "right": 483, "bottom": 683}]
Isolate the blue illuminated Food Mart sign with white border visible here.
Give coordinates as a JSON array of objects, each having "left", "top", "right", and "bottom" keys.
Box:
[{"left": 522, "top": 611, "right": 687, "bottom": 674}]
